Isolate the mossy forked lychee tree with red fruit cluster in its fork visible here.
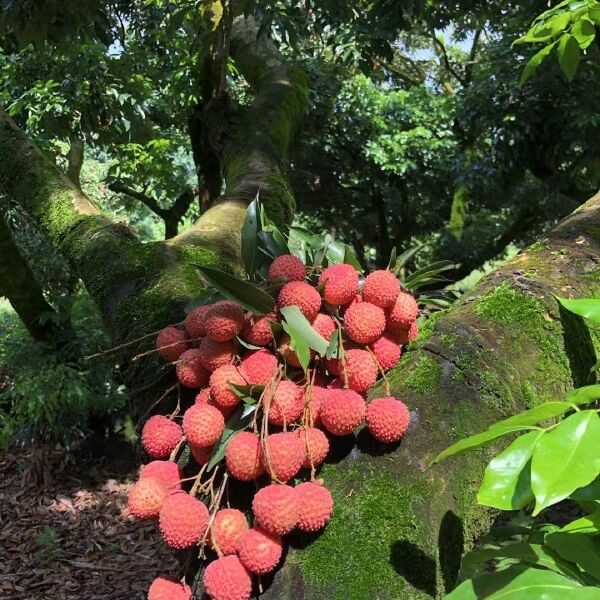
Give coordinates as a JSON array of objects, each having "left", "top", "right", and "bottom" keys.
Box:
[{"left": 0, "top": 1, "right": 600, "bottom": 600}]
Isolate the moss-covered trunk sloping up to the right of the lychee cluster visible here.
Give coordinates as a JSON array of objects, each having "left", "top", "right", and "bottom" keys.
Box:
[{"left": 266, "top": 195, "right": 600, "bottom": 600}]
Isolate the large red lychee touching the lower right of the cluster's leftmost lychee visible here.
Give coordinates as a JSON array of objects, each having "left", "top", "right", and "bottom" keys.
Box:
[{"left": 158, "top": 491, "right": 209, "bottom": 550}]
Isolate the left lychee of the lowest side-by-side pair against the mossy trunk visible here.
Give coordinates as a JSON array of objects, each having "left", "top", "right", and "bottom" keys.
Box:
[{"left": 252, "top": 483, "right": 298, "bottom": 535}]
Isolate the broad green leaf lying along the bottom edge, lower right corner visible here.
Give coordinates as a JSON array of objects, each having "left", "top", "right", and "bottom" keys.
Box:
[{"left": 444, "top": 565, "right": 598, "bottom": 600}]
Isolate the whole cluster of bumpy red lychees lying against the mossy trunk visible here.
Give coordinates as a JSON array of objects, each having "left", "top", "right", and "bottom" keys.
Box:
[{"left": 129, "top": 255, "right": 419, "bottom": 600}]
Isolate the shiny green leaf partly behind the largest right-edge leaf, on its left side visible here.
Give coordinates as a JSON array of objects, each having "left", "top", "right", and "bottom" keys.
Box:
[{"left": 477, "top": 430, "right": 544, "bottom": 510}]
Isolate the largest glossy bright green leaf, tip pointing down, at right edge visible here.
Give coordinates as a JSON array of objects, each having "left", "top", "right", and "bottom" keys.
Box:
[{"left": 531, "top": 410, "right": 600, "bottom": 516}]
